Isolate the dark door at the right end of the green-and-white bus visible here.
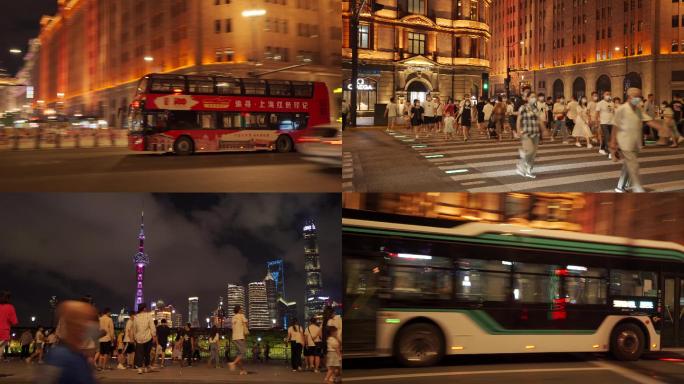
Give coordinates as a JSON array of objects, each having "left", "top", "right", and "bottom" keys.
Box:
[{"left": 660, "top": 274, "right": 684, "bottom": 347}]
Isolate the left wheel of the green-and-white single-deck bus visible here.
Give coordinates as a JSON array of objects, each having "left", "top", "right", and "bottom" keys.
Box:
[{"left": 395, "top": 323, "right": 444, "bottom": 367}]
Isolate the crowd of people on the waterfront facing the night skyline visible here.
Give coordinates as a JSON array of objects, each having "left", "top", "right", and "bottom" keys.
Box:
[{"left": 0, "top": 292, "right": 342, "bottom": 383}]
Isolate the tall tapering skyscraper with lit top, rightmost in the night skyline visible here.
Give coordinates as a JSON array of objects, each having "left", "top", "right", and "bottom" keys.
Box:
[{"left": 303, "top": 220, "right": 323, "bottom": 319}]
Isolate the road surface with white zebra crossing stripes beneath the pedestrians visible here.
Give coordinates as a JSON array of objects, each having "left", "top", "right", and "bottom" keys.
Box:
[{"left": 342, "top": 127, "right": 684, "bottom": 192}]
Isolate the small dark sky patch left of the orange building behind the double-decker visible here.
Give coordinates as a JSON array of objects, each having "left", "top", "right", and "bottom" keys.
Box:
[{"left": 0, "top": 0, "right": 57, "bottom": 75}]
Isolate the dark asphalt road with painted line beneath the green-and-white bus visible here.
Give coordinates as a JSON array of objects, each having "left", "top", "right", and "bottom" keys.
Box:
[{"left": 343, "top": 352, "right": 684, "bottom": 384}]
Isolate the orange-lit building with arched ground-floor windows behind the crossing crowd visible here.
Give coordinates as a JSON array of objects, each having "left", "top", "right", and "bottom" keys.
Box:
[{"left": 491, "top": 0, "right": 684, "bottom": 100}]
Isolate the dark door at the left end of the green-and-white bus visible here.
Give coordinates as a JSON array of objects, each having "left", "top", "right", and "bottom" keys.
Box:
[{"left": 343, "top": 256, "right": 382, "bottom": 354}]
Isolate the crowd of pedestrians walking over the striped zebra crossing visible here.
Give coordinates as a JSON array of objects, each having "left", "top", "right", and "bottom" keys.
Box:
[{"left": 385, "top": 88, "right": 684, "bottom": 192}]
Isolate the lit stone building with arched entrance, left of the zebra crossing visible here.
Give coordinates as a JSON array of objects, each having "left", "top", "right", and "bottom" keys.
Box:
[{"left": 342, "top": 0, "right": 491, "bottom": 124}]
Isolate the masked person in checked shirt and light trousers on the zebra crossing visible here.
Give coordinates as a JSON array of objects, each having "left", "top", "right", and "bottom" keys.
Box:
[{"left": 516, "top": 93, "right": 540, "bottom": 179}]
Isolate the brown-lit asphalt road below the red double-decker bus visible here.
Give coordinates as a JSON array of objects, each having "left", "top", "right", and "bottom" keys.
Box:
[{"left": 0, "top": 148, "right": 341, "bottom": 192}]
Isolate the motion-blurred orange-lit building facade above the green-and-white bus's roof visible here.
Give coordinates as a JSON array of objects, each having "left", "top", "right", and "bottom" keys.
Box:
[{"left": 343, "top": 193, "right": 684, "bottom": 244}]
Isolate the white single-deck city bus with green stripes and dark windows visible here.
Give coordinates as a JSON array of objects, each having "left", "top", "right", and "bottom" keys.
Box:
[{"left": 343, "top": 210, "right": 684, "bottom": 366}]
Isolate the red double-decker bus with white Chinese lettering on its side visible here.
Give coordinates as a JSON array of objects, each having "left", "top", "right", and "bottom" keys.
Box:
[{"left": 128, "top": 74, "right": 330, "bottom": 155}]
